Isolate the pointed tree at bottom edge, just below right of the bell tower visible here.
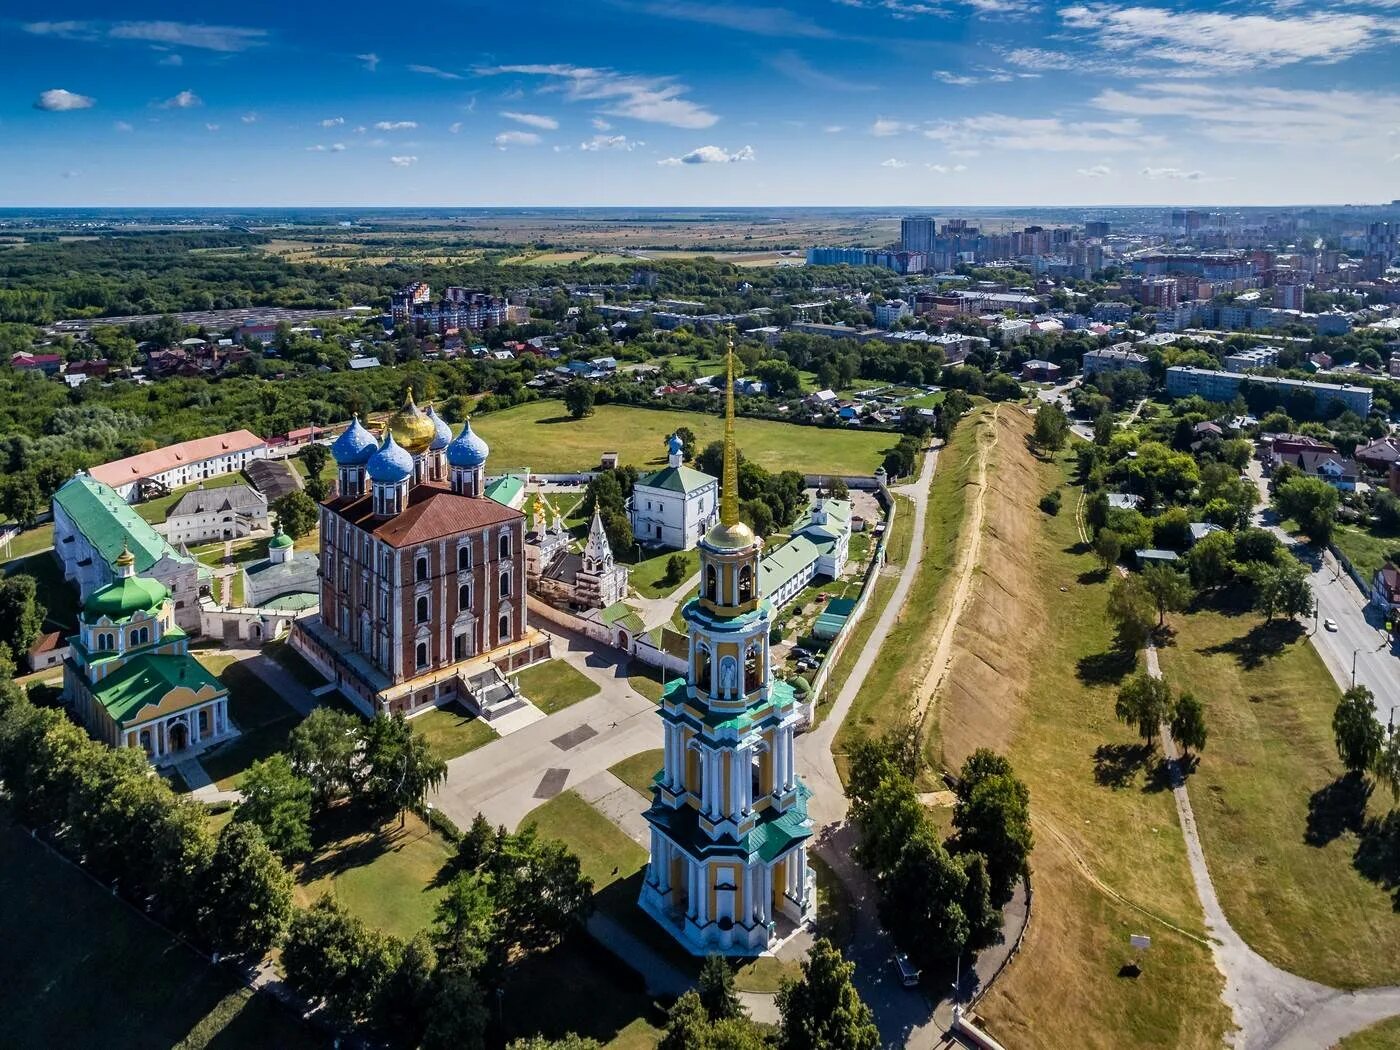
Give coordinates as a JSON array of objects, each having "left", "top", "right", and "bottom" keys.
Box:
[{"left": 777, "top": 937, "right": 879, "bottom": 1050}]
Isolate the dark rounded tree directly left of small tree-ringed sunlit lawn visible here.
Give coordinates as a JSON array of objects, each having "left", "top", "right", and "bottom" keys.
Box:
[{"left": 200, "top": 820, "right": 293, "bottom": 959}]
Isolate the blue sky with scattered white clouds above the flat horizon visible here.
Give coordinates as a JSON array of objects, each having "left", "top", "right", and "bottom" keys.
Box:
[{"left": 0, "top": 0, "right": 1400, "bottom": 207}]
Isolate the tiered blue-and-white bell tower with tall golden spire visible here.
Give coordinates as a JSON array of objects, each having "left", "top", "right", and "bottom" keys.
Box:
[{"left": 640, "top": 343, "right": 816, "bottom": 955}]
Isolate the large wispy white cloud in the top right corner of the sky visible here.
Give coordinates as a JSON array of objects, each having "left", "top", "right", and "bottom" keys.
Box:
[{"left": 1060, "top": 3, "right": 1400, "bottom": 71}]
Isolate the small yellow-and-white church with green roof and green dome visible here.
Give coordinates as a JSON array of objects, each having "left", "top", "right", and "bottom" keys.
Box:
[{"left": 63, "top": 550, "right": 237, "bottom": 764}]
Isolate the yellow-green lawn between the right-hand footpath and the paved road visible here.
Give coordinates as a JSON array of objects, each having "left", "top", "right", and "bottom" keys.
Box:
[{"left": 1161, "top": 599, "right": 1400, "bottom": 988}]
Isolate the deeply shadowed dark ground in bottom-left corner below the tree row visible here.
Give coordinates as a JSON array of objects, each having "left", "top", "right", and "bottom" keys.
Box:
[{"left": 0, "top": 822, "right": 329, "bottom": 1050}]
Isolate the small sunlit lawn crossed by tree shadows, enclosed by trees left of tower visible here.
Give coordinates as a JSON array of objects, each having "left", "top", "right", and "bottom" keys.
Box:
[{"left": 295, "top": 806, "right": 454, "bottom": 939}]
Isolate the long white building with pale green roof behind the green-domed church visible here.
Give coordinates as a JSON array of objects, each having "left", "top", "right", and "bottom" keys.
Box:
[{"left": 53, "top": 470, "right": 205, "bottom": 633}]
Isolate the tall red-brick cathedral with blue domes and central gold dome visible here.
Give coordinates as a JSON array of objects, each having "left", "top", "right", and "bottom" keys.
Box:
[{"left": 291, "top": 393, "right": 549, "bottom": 718}]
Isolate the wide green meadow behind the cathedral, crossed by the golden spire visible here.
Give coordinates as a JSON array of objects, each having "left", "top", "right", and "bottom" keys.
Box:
[{"left": 472, "top": 400, "right": 899, "bottom": 475}]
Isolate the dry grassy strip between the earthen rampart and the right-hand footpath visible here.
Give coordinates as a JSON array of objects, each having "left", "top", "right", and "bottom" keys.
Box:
[{"left": 979, "top": 458, "right": 1229, "bottom": 1050}]
